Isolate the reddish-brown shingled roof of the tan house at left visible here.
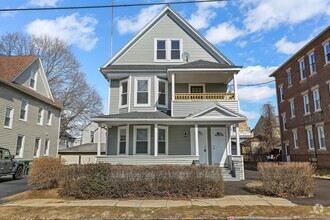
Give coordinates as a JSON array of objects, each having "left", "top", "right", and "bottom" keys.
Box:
[{"left": 0, "top": 55, "right": 38, "bottom": 81}]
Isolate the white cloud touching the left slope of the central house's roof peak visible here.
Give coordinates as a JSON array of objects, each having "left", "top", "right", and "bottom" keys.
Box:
[{"left": 117, "top": 5, "right": 163, "bottom": 35}]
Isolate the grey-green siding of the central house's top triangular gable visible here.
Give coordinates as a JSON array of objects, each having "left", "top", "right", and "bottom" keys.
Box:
[{"left": 115, "top": 15, "right": 217, "bottom": 64}]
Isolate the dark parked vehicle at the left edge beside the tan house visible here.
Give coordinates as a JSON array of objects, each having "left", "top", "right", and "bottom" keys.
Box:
[{"left": 0, "top": 148, "right": 24, "bottom": 180}]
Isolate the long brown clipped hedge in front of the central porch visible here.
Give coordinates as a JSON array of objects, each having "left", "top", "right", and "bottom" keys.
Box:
[{"left": 60, "top": 163, "right": 224, "bottom": 199}]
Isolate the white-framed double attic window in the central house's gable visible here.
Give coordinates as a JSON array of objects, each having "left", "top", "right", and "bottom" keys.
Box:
[{"left": 155, "top": 39, "right": 182, "bottom": 62}]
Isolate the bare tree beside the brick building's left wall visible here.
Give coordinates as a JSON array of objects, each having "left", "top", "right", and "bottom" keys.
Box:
[{"left": 261, "top": 103, "right": 280, "bottom": 152}]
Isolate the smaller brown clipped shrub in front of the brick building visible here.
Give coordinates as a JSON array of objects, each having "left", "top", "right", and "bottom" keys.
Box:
[{"left": 258, "top": 162, "right": 315, "bottom": 197}]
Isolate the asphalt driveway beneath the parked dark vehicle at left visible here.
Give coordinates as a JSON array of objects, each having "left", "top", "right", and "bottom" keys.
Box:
[{"left": 0, "top": 176, "right": 31, "bottom": 204}]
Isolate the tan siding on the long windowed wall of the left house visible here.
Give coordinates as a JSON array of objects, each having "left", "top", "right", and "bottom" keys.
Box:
[{"left": 0, "top": 85, "right": 60, "bottom": 160}]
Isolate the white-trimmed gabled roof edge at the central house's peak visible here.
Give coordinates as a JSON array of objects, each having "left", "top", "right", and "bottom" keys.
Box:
[{"left": 101, "top": 6, "right": 234, "bottom": 70}]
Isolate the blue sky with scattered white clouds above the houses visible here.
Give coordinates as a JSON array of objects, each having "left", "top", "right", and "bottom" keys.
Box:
[{"left": 0, "top": 0, "right": 330, "bottom": 128}]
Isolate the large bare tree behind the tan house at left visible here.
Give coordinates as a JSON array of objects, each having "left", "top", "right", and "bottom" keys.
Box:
[{"left": 0, "top": 32, "right": 102, "bottom": 136}]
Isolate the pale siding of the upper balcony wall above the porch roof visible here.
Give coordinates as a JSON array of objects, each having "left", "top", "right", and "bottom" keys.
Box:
[{"left": 173, "top": 101, "right": 239, "bottom": 117}]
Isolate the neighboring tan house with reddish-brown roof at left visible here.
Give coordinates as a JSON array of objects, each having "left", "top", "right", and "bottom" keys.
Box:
[{"left": 0, "top": 56, "right": 62, "bottom": 160}]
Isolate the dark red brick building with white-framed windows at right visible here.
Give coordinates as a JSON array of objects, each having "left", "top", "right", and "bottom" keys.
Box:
[{"left": 271, "top": 26, "right": 330, "bottom": 167}]
